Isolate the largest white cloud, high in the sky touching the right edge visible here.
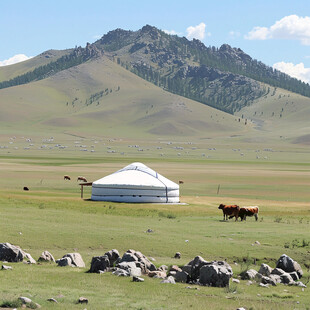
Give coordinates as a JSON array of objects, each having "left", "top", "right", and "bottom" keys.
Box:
[{"left": 245, "top": 15, "right": 310, "bottom": 45}]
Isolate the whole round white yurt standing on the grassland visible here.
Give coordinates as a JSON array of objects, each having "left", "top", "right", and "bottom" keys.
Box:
[{"left": 91, "top": 163, "right": 180, "bottom": 203}]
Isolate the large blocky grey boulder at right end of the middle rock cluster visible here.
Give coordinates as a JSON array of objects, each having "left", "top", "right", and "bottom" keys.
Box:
[{"left": 199, "top": 261, "right": 233, "bottom": 287}]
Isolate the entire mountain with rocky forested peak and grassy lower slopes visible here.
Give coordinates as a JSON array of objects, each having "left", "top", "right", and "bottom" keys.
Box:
[{"left": 0, "top": 25, "right": 310, "bottom": 143}]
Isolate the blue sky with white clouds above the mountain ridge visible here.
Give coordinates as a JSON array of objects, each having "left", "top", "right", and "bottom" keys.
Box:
[{"left": 0, "top": 0, "right": 310, "bottom": 81}]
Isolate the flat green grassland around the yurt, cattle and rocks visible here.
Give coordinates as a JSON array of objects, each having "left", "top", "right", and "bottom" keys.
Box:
[{"left": 0, "top": 142, "right": 310, "bottom": 309}]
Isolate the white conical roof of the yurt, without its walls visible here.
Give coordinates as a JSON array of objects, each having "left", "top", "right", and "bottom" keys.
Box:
[{"left": 93, "top": 163, "right": 179, "bottom": 189}]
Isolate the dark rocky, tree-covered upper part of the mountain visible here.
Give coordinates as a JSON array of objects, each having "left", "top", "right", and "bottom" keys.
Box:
[{"left": 0, "top": 25, "right": 310, "bottom": 114}]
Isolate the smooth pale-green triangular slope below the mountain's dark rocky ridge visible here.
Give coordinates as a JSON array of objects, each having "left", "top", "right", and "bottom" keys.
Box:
[{"left": 0, "top": 57, "right": 246, "bottom": 137}]
